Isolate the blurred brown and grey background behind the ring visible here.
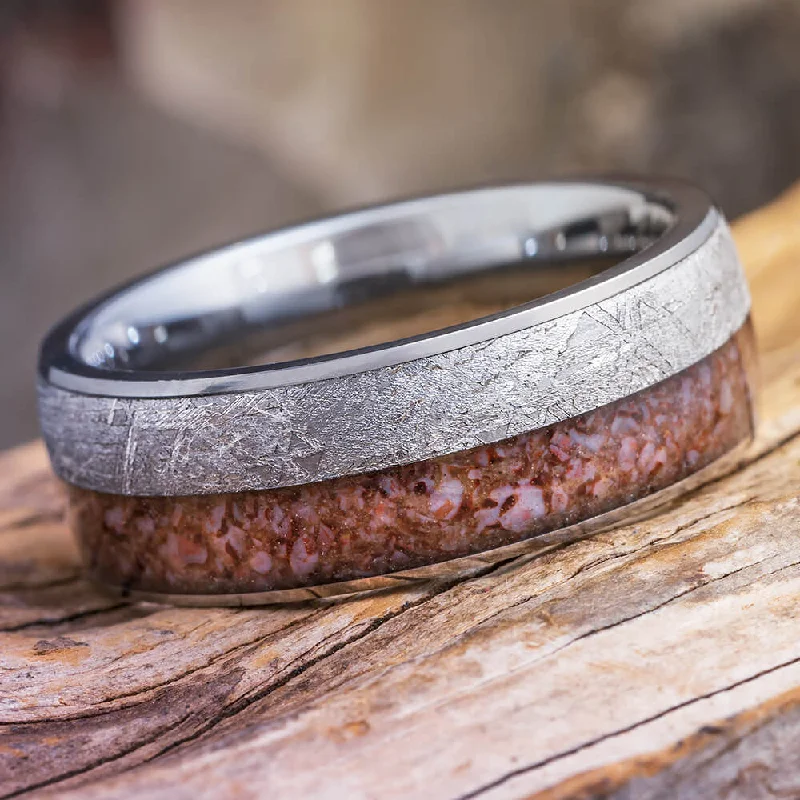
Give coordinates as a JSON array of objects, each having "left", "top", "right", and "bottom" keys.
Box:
[{"left": 0, "top": 0, "right": 800, "bottom": 447}]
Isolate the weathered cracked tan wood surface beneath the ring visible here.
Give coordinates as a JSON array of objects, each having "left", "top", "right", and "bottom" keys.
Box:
[{"left": 0, "top": 183, "right": 800, "bottom": 800}]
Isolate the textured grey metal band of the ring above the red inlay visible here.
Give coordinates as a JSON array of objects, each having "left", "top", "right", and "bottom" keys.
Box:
[{"left": 39, "top": 218, "right": 750, "bottom": 496}]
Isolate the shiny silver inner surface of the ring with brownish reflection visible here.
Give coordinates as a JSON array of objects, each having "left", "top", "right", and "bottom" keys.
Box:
[{"left": 69, "top": 184, "right": 674, "bottom": 373}]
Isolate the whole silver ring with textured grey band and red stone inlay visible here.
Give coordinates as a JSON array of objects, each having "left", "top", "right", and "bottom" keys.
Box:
[{"left": 38, "top": 181, "right": 755, "bottom": 604}]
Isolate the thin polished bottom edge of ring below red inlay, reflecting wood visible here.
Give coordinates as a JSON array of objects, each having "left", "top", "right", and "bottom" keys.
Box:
[{"left": 91, "top": 437, "right": 752, "bottom": 608}]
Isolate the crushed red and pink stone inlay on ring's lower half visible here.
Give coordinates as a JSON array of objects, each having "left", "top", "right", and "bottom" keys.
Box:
[{"left": 70, "top": 325, "right": 752, "bottom": 594}]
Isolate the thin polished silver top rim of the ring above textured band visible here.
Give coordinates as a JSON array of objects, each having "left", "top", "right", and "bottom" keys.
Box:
[{"left": 40, "top": 181, "right": 720, "bottom": 398}]
